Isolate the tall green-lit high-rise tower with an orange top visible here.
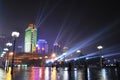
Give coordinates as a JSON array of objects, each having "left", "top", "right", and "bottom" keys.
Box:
[{"left": 24, "top": 24, "right": 37, "bottom": 52}]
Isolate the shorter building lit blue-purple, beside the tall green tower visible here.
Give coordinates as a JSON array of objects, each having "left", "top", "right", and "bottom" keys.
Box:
[{"left": 36, "top": 39, "right": 48, "bottom": 54}]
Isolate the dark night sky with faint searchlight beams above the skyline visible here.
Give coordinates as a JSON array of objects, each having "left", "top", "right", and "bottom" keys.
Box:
[{"left": 0, "top": 0, "right": 120, "bottom": 53}]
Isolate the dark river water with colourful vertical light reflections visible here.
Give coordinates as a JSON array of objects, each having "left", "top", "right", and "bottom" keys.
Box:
[{"left": 0, "top": 67, "right": 120, "bottom": 80}]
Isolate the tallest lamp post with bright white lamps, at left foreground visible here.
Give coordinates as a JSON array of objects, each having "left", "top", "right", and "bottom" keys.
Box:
[{"left": 11, "top": 31, "right": 20, "bottom": 74}]
